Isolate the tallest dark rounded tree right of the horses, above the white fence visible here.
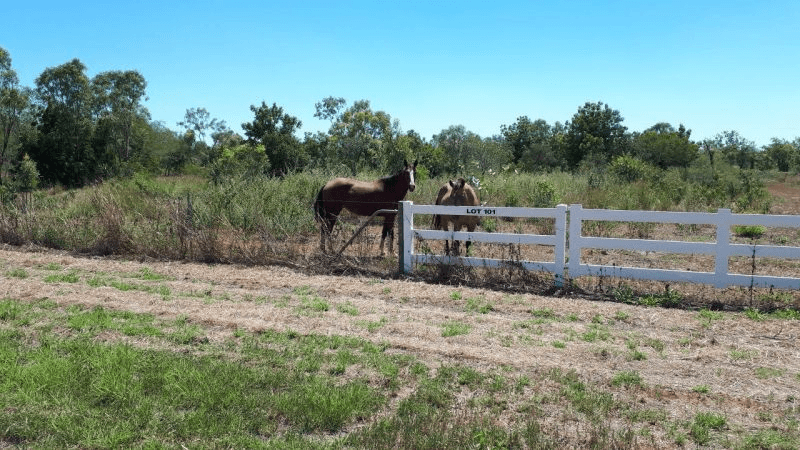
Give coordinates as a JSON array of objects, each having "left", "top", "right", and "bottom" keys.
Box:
[{"left": 565, "top": 102, "right": 628, "bottom": 168}]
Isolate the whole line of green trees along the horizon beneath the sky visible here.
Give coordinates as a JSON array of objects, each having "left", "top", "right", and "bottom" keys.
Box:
[{"left": 0, "top": 48, "right": 800, "bottom": 194}]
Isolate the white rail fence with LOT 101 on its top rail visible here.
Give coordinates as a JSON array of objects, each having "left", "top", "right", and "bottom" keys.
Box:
[{"left": 399, "top": 201, "right": 800, "bottom": 289}]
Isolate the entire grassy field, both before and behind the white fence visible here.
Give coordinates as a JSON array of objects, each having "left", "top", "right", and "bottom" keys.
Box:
[{"left": 0, "top": 169, "right": 800, "bottom": 449}]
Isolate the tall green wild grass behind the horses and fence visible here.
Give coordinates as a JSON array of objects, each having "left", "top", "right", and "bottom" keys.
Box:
[{"left": 0, "top": 158, "right": 769, "bottom": 263}]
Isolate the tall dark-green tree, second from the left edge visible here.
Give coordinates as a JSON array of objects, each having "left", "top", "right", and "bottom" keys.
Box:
[{"left": 23, "top": 59, "right": 98, "bottom": 186}]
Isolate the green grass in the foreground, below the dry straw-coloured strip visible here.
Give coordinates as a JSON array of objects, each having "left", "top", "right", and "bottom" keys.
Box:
[{"left": 0, "top": 296, "right": 798, "bottom": 449}]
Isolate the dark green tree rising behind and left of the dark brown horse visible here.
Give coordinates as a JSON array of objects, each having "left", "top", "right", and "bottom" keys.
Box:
[{"left": 242, "top": 102, "right": 310, "bottom": 174}]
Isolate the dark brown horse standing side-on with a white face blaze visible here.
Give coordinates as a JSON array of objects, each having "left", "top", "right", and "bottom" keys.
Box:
[{"left": 314, "top": 161, "right": 417, "bottom": 256}]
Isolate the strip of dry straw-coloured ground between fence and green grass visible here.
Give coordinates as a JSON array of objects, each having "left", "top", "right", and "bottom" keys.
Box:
[{"left": 0, "top": 176, "right": 800, "bottom": 442}]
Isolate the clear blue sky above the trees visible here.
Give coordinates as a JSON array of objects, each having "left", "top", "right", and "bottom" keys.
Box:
[{"left": 0, "top": 0, "right": 800, "bottom": 146}]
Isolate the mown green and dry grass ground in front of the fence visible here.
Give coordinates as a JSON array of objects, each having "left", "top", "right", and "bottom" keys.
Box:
[{"left": 0, "top": 252, "right": 800, "bottom": 449}]
